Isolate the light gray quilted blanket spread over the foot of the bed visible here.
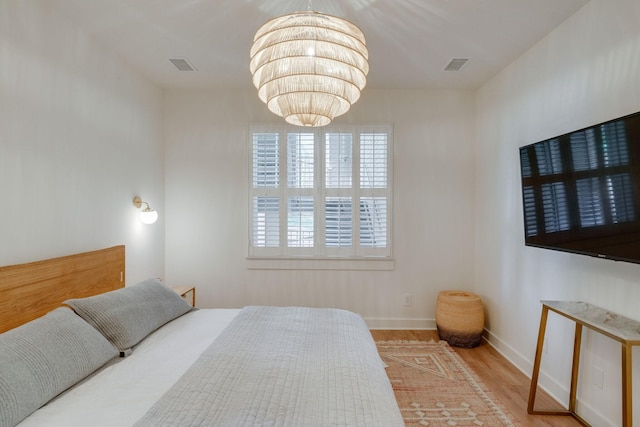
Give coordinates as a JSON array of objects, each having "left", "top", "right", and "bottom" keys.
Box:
[{"left": 136, "top": 307, "right": 404, "bottom": 427}]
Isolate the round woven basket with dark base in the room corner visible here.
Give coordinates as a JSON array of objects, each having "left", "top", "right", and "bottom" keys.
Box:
[{"left": 436, "top": 291, "right": 484, "bottom": 348}]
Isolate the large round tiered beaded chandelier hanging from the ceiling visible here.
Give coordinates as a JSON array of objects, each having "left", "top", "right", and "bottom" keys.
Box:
[{"left": 249, "top": 11, "right": 369, "bottom": 126}]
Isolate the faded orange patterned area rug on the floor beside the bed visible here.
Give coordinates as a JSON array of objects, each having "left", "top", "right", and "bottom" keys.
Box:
[{"left": 376, "top": 341, "right": 519, "bottom": 427}]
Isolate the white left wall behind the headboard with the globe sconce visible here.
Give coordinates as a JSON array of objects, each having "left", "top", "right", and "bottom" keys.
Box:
[{"left": 0, "top": 0, "right": 165, "bottom": 284}]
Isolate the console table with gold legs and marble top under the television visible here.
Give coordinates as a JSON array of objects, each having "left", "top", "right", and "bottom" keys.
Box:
[{"left": 527, "top": 301, "right": 640, "bottom": 427}]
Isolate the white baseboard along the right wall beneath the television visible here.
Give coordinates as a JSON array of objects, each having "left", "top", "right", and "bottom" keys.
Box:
[{"left": 483, "top": 329, "right": 616, "bottom": 427}]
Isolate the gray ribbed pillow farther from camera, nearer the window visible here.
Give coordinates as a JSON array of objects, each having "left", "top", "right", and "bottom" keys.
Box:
[{"left": 64, "top": 279, "right": 192, "bottom": 352}]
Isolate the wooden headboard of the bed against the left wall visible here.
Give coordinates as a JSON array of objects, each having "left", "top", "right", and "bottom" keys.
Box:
[{"left": 0, "top": 246, "right": 125, "bottom": 333}]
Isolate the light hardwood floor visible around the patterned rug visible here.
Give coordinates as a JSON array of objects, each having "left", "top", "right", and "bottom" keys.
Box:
[{"left": 371, "top": 330, "right": 581, "bottom": 427}]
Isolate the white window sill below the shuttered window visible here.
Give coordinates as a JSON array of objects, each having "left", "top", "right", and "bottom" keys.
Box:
[{"left": 246, "top": 257, "right": 396, "bottom": 271}]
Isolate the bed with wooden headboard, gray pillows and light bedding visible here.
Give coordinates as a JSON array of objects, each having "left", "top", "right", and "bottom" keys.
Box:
[{"left": 0, "top": 246, "right": 404, "bottom": 427}]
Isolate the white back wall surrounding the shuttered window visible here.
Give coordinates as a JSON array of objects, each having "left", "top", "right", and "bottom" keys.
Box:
[{"left": 165, "top": 89, "right": 474, "bottom": 327}]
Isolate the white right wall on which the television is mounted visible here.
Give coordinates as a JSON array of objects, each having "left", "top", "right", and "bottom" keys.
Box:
[{"left": 475, "top": 0, "right": 640, "bottom": 426}]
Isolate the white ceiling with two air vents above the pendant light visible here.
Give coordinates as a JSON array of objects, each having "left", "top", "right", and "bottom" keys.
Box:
[{"left": 41, "top": 0, "right": 588, "bottom": 89}]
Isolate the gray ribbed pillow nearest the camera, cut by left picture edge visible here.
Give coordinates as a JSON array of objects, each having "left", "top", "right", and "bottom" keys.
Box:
[{"left": 0, "top": 307, "right": 118, "bottom": 427}]
